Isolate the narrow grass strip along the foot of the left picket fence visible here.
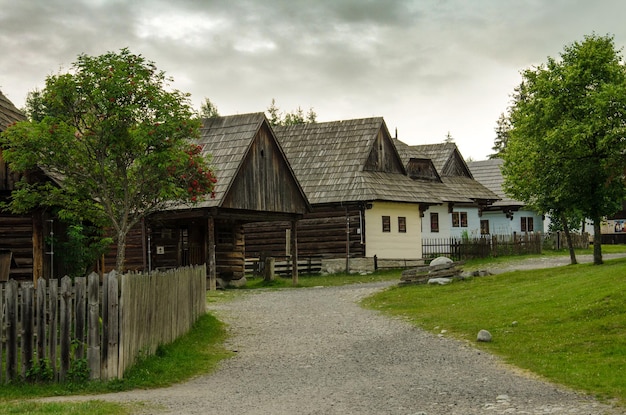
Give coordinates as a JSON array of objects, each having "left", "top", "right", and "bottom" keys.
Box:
[{"left": 0, "top": 314, "right": 232, "bottom": 404}]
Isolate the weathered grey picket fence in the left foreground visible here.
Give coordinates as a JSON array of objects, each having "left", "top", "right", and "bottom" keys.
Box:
[{"left": 0, "top": 265, "right": 206, "bottom": 383}]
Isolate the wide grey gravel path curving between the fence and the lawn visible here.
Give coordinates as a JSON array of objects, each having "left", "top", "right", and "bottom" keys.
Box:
[{"left": 39, "top": 255, "right": 623, "bottom": 415}]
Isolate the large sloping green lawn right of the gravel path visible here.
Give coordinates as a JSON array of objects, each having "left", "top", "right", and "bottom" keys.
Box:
[{"left": 364, "top": 259, "right": 626, "bottom": 404}]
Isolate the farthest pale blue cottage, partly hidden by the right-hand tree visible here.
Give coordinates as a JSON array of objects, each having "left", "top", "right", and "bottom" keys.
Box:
[{"left": 468, "top": 158, "right": 543, "bottom": 235}]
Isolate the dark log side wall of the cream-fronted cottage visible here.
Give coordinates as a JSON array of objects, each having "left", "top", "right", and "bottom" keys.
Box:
[{"left": 244, "top": 205, "right": 365, "bottom": 258}]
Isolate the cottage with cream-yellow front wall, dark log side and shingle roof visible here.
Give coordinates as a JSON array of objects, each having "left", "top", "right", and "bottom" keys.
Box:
[{"left": 245, "top": 117, "right": 441, "bottom": 272}]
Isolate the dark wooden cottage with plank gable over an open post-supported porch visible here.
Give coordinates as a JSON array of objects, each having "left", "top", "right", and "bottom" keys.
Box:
[{"left": 116, "top": 113, "right": 309, "bottom": 286}]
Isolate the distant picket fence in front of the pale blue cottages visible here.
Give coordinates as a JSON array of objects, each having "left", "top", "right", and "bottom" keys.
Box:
[{"left": 422, "top": 233, "right": 542, "bottom": 261}]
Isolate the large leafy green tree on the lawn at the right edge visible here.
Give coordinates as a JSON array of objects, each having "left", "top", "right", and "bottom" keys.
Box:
[{"left": 502, "top": 35, "right": 626, "bottom": 264}]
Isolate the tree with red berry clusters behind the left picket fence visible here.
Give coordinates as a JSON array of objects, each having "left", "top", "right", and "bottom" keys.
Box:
[{"left": 2, "top": 49, "right": 215, "bottom": 271}]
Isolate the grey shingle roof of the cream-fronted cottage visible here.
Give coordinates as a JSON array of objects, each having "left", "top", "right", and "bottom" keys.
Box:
[{"left": 274, "top": 117, "right": 441, "bottom": 204}]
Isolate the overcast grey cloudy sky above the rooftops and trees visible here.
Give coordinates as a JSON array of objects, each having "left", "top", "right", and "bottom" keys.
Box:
[{"left": 0, "top": 0, "right": 626, "bottom": 160}]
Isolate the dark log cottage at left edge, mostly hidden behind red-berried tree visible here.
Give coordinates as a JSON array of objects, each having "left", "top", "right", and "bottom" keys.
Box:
[{"left": 0, "top": 92, "right": 49, "bottom": 281}]
